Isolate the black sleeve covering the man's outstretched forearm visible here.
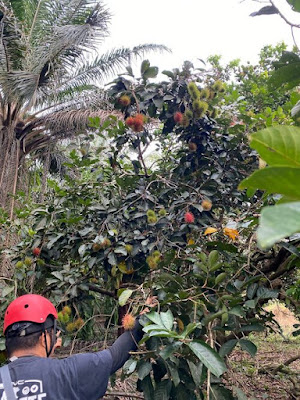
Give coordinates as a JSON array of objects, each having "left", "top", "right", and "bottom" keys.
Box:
[{"left": 108, "top": 319, "right": 143, "bottom": 374}]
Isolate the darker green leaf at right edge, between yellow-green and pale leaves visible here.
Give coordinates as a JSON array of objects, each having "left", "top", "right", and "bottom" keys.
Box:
[{"left": 239, "top": 167, "right": 300, "bottom": 200}]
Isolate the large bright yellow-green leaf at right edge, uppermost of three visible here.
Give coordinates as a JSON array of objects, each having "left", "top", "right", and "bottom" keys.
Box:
[{"left": 250, "top": 125, "right": 300, "bottom": 167}]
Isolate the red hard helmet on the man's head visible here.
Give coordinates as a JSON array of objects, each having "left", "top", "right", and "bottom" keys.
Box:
[{"left": 3, "top": 294, "right": 57, "bottom": 334}]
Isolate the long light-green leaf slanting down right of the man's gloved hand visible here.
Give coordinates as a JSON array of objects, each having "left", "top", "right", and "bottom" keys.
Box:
[{"left": 186, "top": 341, "right": 227, "bottom": 377}]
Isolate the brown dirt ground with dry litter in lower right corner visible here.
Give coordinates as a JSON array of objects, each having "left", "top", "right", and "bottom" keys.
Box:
[{"left": 226, "top": 303, "right": 300, "bottom": 400}]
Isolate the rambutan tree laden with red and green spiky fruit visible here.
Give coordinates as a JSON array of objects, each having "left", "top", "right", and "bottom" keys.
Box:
[{"left": 1, "top": 57, "right": 296, "bottom": 400}]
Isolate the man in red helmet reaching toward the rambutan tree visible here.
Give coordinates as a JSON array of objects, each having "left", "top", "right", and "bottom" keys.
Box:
[{"left": 0, "top": 294, "right": 143, "bottom": 400}]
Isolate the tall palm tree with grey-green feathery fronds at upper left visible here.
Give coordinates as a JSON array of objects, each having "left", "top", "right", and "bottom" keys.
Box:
[{"left": 0, "top": 0, "right": 166, "bottom": 216}]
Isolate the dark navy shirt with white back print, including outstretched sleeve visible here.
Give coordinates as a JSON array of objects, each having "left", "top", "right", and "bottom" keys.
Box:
[{"left": 0, "top": 321, "right": 142, "bottom": 400}]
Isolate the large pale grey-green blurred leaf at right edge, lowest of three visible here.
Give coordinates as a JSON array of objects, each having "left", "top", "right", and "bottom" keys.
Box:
[{"left": 257, "top": 202, "right": 300, "bottom": 249}]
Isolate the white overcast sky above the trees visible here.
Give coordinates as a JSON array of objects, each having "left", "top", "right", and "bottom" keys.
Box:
[{"left": 101, "top": 0, "right": 300, "bottom": 71}]
